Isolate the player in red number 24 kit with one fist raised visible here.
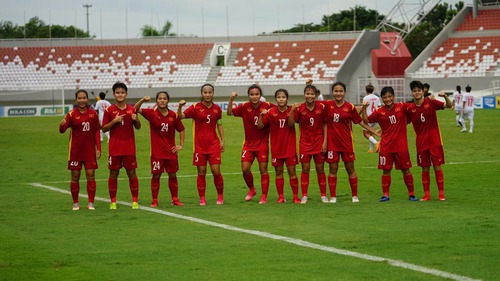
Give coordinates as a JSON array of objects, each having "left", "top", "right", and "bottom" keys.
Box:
[{"left": 135, "top": 91, "right": 185, "bottom": 208}]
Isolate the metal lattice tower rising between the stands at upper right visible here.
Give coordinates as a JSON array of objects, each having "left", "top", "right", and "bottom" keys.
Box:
[{"left": 377, "top": 0, "right": 441, "bottom": 54}]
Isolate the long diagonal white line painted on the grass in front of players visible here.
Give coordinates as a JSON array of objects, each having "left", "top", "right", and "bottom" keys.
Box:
[{"left": 30, "top": 183, "right": 480, "bottom": 281}]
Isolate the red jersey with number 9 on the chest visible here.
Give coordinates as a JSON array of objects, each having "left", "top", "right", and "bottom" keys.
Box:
[{"left": 293, "top": 101, "right": 326, "bottom": 155}]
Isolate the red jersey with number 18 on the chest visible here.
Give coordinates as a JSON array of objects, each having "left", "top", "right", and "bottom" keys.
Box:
[{"left": 326, "top": 100, "right": 363, "bottom": 152}]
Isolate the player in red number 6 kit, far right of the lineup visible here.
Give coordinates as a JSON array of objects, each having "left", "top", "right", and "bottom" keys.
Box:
[{"left": 407, "top": 81, "right": 452, "bottom": 201}]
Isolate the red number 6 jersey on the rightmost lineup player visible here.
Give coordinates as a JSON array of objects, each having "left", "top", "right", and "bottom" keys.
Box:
[{"left": 407, "top": 98, "right": 444, "bottom": 152}]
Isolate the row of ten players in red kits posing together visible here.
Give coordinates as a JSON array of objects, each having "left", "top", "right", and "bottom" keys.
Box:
[{"left": 59, "top": 77, "right": 452, "bottom": 210}]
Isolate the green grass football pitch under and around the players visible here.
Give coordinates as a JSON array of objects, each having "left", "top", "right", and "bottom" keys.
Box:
[{"left": 0, "top": 107, "right": 500, "bottom": 280}]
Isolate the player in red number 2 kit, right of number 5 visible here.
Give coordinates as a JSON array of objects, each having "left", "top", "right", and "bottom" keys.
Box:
[{"left": 227, "top": 84, "right": 275, "bottom": 204}]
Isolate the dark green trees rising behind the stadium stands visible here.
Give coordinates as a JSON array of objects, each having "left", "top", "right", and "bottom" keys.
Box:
[{"left": 0, "top": 1, "right": 464, "bottom": 58}]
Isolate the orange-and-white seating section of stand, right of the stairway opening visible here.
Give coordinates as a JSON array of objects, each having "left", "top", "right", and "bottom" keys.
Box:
[{"left": 216, "top": 39, "right": 355, "bottom": 85}]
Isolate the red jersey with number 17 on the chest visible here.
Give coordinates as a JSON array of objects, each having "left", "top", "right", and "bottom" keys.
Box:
[{"left": 262, "top": 106, "right": 297, "bottom": 158}]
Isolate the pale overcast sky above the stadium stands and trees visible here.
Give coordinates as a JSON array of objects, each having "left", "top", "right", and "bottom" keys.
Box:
[{"left": 0, "top": 0, "right": 472, "bottom": 39}]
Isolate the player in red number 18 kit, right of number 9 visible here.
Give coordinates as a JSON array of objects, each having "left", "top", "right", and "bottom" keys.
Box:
[{"left": 326, "top": 82, "right": 380, "bottom": 203}]
